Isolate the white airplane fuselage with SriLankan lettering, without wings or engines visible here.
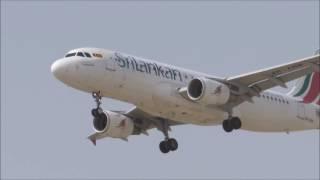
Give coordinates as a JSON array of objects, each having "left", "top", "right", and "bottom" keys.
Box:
[{"left": 53, "top": 51, "right": 319, "bottom": 132}]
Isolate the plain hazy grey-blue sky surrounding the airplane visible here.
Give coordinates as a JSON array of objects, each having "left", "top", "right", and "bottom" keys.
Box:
[{"left": 1, "top": 1, "right": 319, "bottom": 179}]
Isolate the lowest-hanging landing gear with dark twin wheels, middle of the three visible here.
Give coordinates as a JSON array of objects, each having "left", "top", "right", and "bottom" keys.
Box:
[{"left": 159, "top": 119, "right": 178, "bottom": 153}]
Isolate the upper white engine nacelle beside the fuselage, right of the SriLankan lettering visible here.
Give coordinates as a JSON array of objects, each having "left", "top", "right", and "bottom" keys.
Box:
[{"left": 187, "top": 78, "right": 230, "bottom": 105}]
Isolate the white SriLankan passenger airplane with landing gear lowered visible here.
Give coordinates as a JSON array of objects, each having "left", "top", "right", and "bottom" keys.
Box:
[{"left": 51, "top": 48, "right": 320, "bottom": 153}]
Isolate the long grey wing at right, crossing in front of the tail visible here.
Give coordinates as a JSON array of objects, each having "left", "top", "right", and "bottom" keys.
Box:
[{"left": 218, "top": 54, "right": 320, "bottom": 105}]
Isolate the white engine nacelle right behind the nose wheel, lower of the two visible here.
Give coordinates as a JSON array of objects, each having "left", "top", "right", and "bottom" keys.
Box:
[{"left": 93, "top": 111, "right": 134, "bottom": 138}]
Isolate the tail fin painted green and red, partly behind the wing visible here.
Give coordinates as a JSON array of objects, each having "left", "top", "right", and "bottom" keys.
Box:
[{"left": 288, "top": 50, "right": 320, "bottom": 105}]
